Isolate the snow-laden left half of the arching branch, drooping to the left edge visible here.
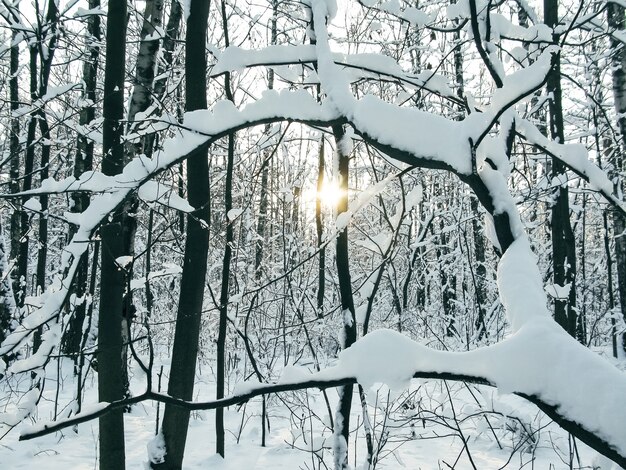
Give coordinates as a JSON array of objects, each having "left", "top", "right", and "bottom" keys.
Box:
[{"left": 0, "top": 91, "right": 341, "bottom": 373}]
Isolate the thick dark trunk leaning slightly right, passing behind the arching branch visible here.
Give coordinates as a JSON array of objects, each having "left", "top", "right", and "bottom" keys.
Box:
[{"left": 152, "top": 0, "right": 209, "bottom": 470}]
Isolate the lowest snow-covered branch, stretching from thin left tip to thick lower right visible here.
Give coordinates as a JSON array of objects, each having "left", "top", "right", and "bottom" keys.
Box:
[{"left": 20, "top": 328, "right": 626, "bottom": 466}]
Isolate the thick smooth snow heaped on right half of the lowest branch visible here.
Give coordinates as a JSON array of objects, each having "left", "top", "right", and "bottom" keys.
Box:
[{"left": 310, "top": 324, "right": 626, "bottom": 454}]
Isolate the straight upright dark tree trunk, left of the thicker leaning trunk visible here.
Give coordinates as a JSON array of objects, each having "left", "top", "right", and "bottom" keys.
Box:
[{"left": 97, "top": 0, "right": 126, "bottom": 464}]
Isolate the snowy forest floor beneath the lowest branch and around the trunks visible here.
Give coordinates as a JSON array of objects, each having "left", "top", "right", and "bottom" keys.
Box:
[{"left": 0, "top": 354, "right": 626, "bottom": 470}]
